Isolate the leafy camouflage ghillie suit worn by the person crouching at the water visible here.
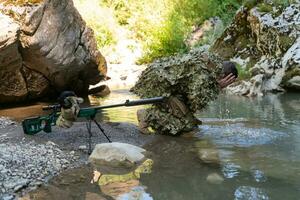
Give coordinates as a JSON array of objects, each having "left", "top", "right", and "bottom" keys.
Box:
[{"left": 131, "top": 49, "right": 222, "bottom": 135}]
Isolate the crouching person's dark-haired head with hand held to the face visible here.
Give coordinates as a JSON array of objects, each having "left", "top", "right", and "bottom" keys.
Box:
[{"left": 218, "top": 61, "right": 238, "bottom": 88}]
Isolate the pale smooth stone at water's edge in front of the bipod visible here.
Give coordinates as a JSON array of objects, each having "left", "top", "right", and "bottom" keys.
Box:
[{"left": 89, "top": 142, "right": 146, "bottom": 174}]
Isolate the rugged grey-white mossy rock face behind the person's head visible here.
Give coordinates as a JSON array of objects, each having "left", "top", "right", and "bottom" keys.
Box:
[{"left": 211, "top": 3, "right": 300, "bottom": 96}]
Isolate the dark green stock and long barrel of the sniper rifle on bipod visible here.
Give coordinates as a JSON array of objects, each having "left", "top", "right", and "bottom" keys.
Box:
[{"left": 22, "top": 97, "right": 165, "bottom": 135}]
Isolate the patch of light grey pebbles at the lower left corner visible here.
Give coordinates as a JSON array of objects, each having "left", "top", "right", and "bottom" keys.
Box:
[{"left": 0, "top": 139, "right": 79, "bottom": 197}]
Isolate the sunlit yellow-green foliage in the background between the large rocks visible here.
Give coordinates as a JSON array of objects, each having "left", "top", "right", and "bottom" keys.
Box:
[{"left": 74, "top": 0, "right": 242, "bottom": 63}]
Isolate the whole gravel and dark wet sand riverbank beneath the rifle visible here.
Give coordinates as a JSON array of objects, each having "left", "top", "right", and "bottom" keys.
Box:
[{"left": 0, "top": 117, "right": 153, "bottom": 200}]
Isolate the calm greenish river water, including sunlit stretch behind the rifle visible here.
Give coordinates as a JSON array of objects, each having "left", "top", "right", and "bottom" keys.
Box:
[{"left": 25, "top": 90, "right": 300, "bottom": 200}]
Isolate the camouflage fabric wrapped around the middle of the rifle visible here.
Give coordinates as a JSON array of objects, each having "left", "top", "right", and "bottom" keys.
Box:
[{"left": 56, "top": 96, "right": 83, "bottom": 128}]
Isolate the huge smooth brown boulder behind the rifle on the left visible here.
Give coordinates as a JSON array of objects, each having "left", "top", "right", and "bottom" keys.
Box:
[{"left": 0, "top": 0, "right": 106, "bottom": 103}]
